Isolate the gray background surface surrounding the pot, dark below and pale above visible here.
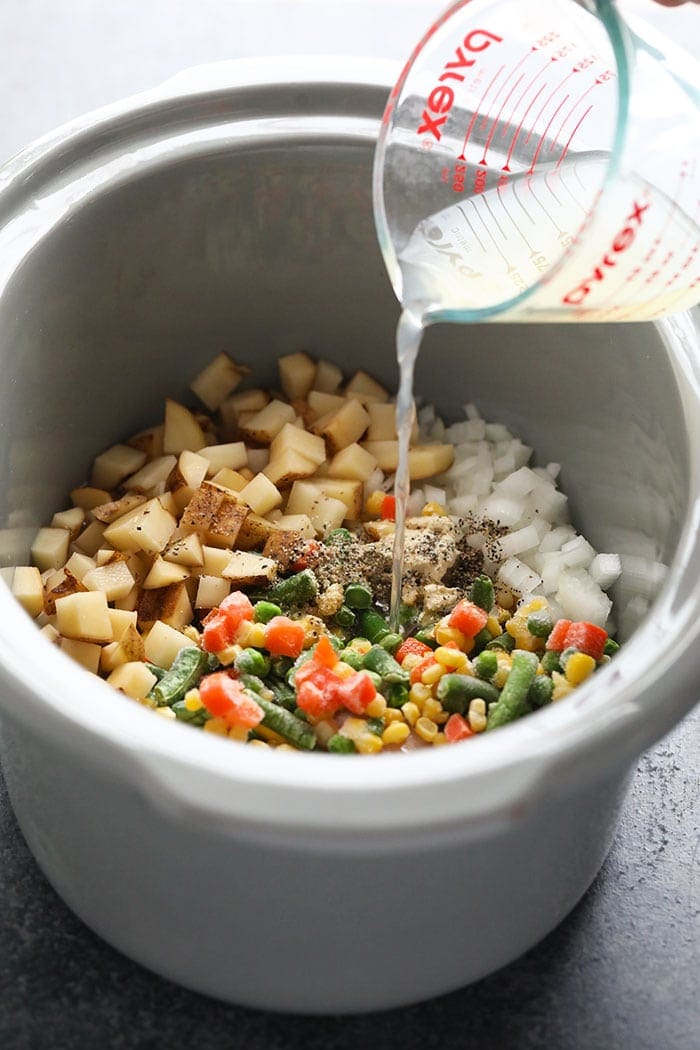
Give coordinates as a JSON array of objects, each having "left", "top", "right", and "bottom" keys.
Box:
[{"left": 0, "top": 0, "right": 700, "bottom": 1050}]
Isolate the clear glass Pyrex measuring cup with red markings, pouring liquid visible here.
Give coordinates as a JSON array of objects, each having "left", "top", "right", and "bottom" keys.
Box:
[{"left": 374, "top": 0, "right": 700, "bottom": 323}]
